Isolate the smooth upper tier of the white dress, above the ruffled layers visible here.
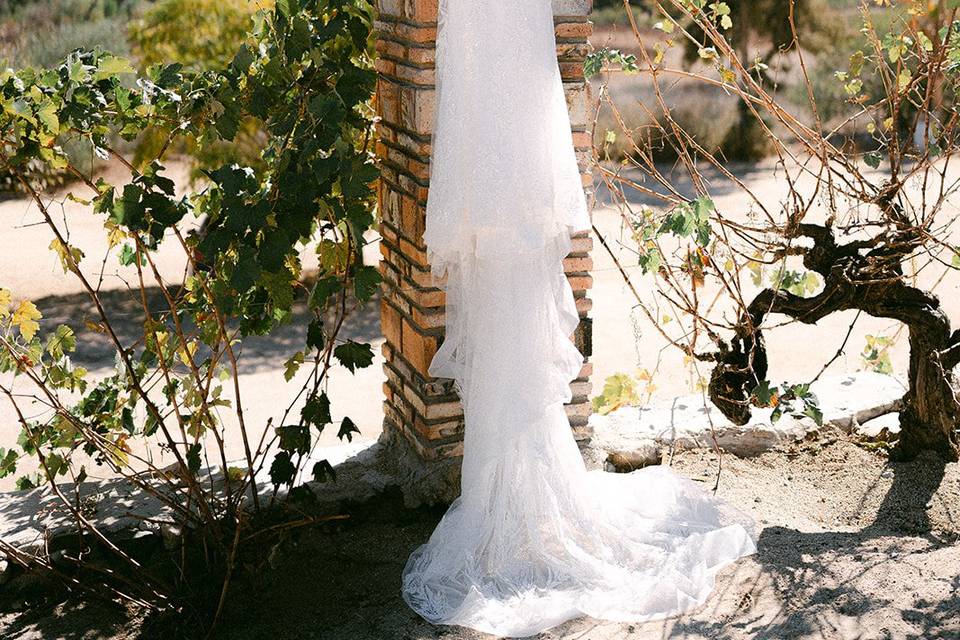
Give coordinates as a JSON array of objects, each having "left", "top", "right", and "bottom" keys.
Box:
[{"left": 424, "top": 0, "right": 590, "bottom": 274}]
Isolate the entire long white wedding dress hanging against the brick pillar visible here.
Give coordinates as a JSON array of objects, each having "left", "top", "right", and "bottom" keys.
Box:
[{"left": 403, "top": 0, "right": 755, "bottom": 636}]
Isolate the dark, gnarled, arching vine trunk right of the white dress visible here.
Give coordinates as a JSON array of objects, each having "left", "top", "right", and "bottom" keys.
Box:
[{"left": 709, "top": 224, "right": 960, "bottom": 460}]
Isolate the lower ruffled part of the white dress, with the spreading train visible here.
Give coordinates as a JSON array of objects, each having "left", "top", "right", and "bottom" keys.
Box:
[{"left": 403, "top": 236, "right": 754, "bottom": 636}]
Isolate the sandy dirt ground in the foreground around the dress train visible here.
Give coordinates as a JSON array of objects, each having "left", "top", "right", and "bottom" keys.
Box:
[{"left": 0, "top": 440, "right": 960, "bottom": 640}]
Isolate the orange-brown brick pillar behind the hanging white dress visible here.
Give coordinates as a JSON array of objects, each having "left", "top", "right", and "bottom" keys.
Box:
[{"left": 376, "top": 0, "right": 593, "bottom": 502}]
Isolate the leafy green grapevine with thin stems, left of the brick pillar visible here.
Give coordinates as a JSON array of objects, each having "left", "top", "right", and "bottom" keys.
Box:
[{"left": 0, "top": 0, "right": 380, "bottom": 624}]
